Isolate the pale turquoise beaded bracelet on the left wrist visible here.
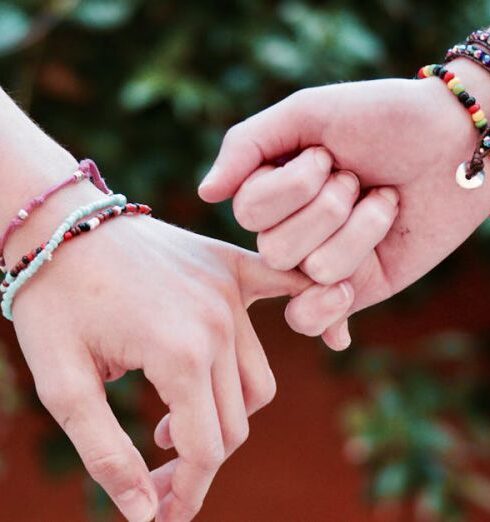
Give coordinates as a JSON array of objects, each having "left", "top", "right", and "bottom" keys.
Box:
[{"left": 1, "top": 194, "right": 127, "bottom": 321}]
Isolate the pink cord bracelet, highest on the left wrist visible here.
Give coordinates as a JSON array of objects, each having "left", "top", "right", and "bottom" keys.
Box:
[{"left": 0, "top": 159, "right": 112, "bottom": 273}]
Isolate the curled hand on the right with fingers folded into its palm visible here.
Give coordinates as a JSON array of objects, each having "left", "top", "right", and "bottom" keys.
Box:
[{"left": 200, "top": 55, "right": 490, "bottom": 348}]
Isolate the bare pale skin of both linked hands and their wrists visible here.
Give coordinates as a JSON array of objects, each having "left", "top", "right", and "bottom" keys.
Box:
[{"left": 0, "top": 53, "right": 490, "bottom": 521}]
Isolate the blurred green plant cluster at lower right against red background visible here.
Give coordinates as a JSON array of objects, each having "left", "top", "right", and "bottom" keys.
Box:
[{"left": 345, "top": 334, "right": 490, "bottom": 522}]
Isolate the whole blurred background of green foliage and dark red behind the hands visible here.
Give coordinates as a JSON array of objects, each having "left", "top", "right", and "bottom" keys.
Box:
[{"left": 0, "top": 0, "right": 490, "bottom": 522}]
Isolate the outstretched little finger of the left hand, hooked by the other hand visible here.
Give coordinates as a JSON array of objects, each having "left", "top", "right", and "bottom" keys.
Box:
[{"left": 238, "top": 250, "right": 314, "bottom": 307}]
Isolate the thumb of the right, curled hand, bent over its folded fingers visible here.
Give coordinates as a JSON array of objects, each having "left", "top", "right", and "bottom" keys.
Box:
[{"left": 198, "top": 91, "right": 321, "bottom": 203}]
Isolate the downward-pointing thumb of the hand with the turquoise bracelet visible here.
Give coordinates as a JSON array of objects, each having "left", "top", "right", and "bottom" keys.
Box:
[{"left": 33, "top": 351, "right": 157, "bottom": 522}]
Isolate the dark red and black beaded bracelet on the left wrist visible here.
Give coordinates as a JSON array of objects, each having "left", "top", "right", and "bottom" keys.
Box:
[{"left": 0, "top": 203, "right": 152, "bottom": 293}]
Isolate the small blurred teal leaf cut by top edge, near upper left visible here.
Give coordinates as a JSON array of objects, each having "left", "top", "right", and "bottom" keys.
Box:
[{"left": 72, "top": 0, "right": 139, "bottom": 29}]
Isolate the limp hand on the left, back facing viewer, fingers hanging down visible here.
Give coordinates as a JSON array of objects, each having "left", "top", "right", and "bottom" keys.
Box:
[{"left": 7, "top": 195, "right": 310, "bottom": 522}]
